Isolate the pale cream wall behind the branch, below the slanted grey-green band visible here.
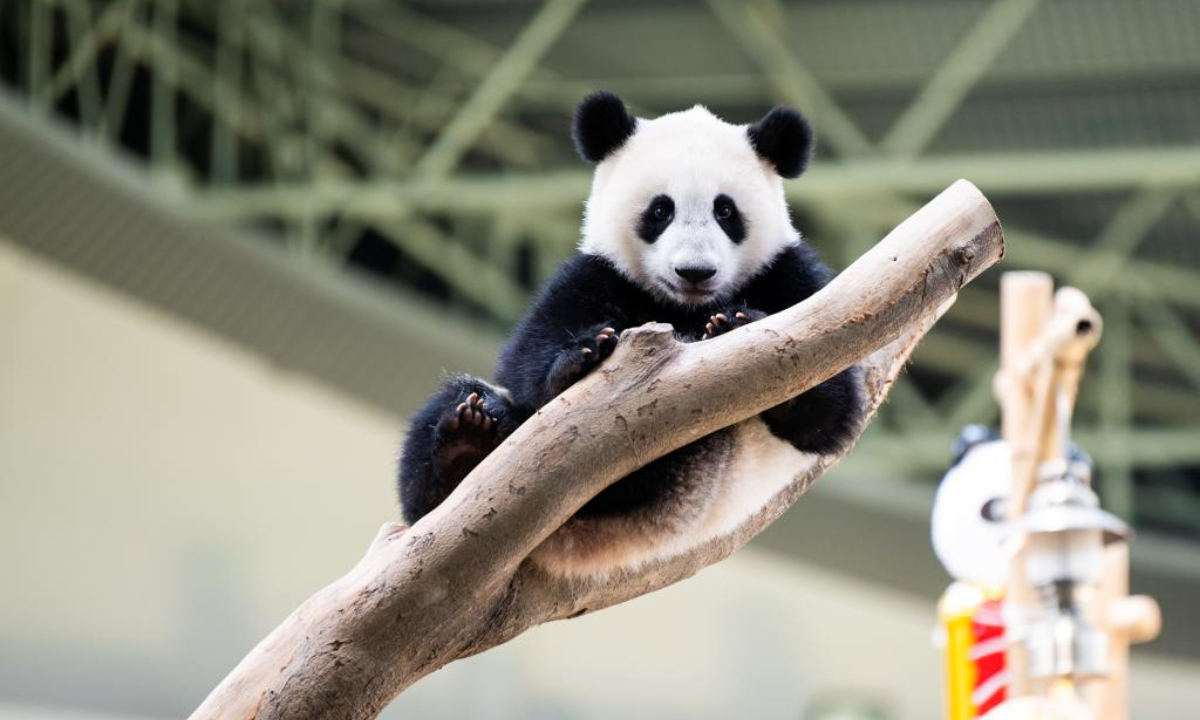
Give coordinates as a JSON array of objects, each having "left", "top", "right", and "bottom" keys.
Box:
[{"left": 0, "top": 241, "right": 1200, "bottom": 720}]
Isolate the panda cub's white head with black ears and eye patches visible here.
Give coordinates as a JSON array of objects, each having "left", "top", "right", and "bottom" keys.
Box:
[{"left": 572, "top": 92, "right": 812, "bottom": 306}]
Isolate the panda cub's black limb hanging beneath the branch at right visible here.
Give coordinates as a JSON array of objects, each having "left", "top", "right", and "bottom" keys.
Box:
[{"left": 762, "top": 367, "right": 864, "bottom": 455}]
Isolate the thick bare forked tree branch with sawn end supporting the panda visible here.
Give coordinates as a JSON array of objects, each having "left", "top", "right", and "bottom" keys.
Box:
[{"left": 192, "top": 180, "right": 1003, "bottom": 720}]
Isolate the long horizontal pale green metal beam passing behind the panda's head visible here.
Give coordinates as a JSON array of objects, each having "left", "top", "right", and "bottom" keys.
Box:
[{"left": 198, "top": 146, "right": 1200, "bottom": 217}]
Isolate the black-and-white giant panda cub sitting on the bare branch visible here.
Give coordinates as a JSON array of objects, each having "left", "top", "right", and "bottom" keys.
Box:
[{"left": 400, "top": 92, "right": 863, "bottom": 576}]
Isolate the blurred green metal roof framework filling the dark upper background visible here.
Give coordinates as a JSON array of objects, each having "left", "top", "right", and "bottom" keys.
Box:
[{"left": 0, "top": 0, "right": 1200, "bottom": 538}]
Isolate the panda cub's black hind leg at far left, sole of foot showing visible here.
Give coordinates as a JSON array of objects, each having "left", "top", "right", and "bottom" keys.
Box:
[{"left": 400, "top": 376, "right": 524, "bottom": 523}]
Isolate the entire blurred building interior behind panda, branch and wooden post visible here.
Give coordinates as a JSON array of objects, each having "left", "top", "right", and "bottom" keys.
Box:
[{"left": 0, "top": 0, "right": 1200, "bottom": 720}]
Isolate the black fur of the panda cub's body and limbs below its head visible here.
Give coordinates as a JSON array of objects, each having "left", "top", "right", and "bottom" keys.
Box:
[{"left": 400, "top": 245, "right": 863, "bottom": 522}]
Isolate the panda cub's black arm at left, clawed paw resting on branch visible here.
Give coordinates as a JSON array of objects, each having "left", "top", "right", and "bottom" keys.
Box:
[{"left": 496, "top": 254, "right": 641, "bottom": 413}]
